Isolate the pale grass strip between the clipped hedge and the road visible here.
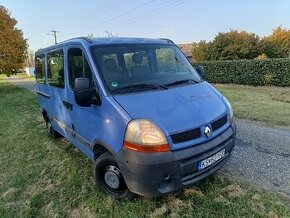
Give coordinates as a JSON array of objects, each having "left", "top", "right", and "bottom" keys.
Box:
[{"left": 215, "top": 84, "right": 290, "bottom": 127}]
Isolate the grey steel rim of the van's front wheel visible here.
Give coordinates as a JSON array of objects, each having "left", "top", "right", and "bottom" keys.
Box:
[{"left": 102, "top": 165, "right": 127, "bottom": 193}]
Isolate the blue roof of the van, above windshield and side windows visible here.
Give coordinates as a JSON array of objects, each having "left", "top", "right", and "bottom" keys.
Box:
[{"left": 36, "top": 37, "right": 173, "bottom": 53}]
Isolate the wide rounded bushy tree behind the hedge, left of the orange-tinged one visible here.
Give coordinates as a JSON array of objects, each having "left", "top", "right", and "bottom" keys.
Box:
[{"left": 211, "top": 30, "right": 261, "bottom": 60}]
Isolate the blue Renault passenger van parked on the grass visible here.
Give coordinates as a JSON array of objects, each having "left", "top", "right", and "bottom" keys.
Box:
[{"left": 35, "top": 37, "right": 236, "bottom": 199}]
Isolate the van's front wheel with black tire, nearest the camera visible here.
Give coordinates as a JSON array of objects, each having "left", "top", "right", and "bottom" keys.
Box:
[{"left": 94, "top": 151, "right": 134, "bottom": 200}]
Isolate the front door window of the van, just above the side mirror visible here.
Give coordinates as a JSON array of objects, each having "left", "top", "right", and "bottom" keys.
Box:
[{"left": 68, "top": 48, "right": 94, "bottom": 89}]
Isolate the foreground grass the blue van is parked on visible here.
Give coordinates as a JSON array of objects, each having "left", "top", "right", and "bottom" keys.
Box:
[{"left": 0, "top": 77, "right": 290, "bottom": 218}]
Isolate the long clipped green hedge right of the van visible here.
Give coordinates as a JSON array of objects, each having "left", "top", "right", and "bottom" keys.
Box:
[{"left": 194, "top": 58, "right": 290, "bottom": 86}]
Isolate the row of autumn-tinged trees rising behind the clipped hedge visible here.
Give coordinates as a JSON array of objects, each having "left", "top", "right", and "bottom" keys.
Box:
[{"left": 192, "top": 26, "right": 290, "bottom": 61}]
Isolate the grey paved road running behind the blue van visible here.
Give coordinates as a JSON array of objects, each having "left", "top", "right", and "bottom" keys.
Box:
[{"left": 4, "top": 77, "right": 290, "bottom": 197}]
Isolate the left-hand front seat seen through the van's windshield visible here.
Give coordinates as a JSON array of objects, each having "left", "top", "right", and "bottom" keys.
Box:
[{"left": 103, "top": 59, "right": 122, "bottom": 80}]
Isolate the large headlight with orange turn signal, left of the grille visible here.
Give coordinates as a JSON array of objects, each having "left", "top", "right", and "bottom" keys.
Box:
[{"left": 124, "top": 119, "right": 169, "bottom": 152}]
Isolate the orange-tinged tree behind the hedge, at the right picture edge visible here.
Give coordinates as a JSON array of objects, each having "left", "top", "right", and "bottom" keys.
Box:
[{"left": 261, "top": 26, "right": 290, "bottom": 58}]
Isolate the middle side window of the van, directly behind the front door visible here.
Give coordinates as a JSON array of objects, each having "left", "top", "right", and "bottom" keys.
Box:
[{"left": 47, "top": 50, "right": 64, "bottom": 88}]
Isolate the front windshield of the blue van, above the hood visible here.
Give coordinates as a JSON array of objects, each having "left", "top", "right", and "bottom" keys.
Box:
[{"left": 92, "top": 44, "right": 201, "bottom": 94}]
